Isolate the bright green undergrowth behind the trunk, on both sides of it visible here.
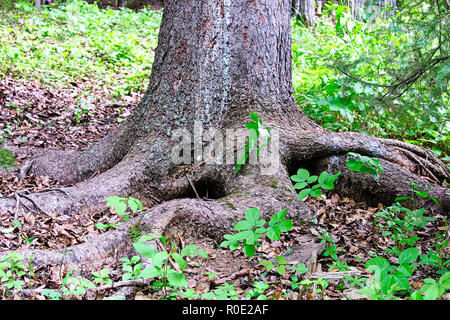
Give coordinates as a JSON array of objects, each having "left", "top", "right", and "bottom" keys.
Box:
[{"left": 0, "top": 0, "right": 450, "bottom": 160}]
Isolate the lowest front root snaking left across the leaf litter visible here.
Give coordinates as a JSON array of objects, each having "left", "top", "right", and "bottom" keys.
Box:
[{"left": 0, "top": 175, "right": 310, "bottom": 271}]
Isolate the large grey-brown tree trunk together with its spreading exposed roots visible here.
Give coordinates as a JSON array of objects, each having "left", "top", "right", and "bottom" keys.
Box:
[{"left": 0, "top": 0, "right": 450, "bottom": 280}]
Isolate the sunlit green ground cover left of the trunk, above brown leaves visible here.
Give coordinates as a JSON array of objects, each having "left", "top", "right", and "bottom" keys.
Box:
[{"left": 0, "top": 0, "right": 161, "bottom": 97}]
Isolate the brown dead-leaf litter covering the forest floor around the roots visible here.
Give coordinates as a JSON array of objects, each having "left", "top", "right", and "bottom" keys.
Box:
[{"left": 0, "top": 77, "right": 450, "bottom": 300}]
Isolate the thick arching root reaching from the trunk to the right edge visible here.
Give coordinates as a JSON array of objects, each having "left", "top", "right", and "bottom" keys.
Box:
[{"left": 285, "top": 132, "right": 450, "bottom": 214}]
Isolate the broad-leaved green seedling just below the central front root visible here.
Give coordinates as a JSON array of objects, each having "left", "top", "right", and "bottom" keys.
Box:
[{"left": 220, "top": 208, "right": 292, "bottom": 258}]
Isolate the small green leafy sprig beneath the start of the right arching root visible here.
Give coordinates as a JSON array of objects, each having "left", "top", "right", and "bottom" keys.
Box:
[{"left": 291, "top": 169, "right": 340, "bottom": 200}]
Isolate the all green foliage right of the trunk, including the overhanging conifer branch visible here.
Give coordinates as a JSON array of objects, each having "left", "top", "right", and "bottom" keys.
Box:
[{"left": 292, "top": 5, "right": 450, "bottom": 156}]
